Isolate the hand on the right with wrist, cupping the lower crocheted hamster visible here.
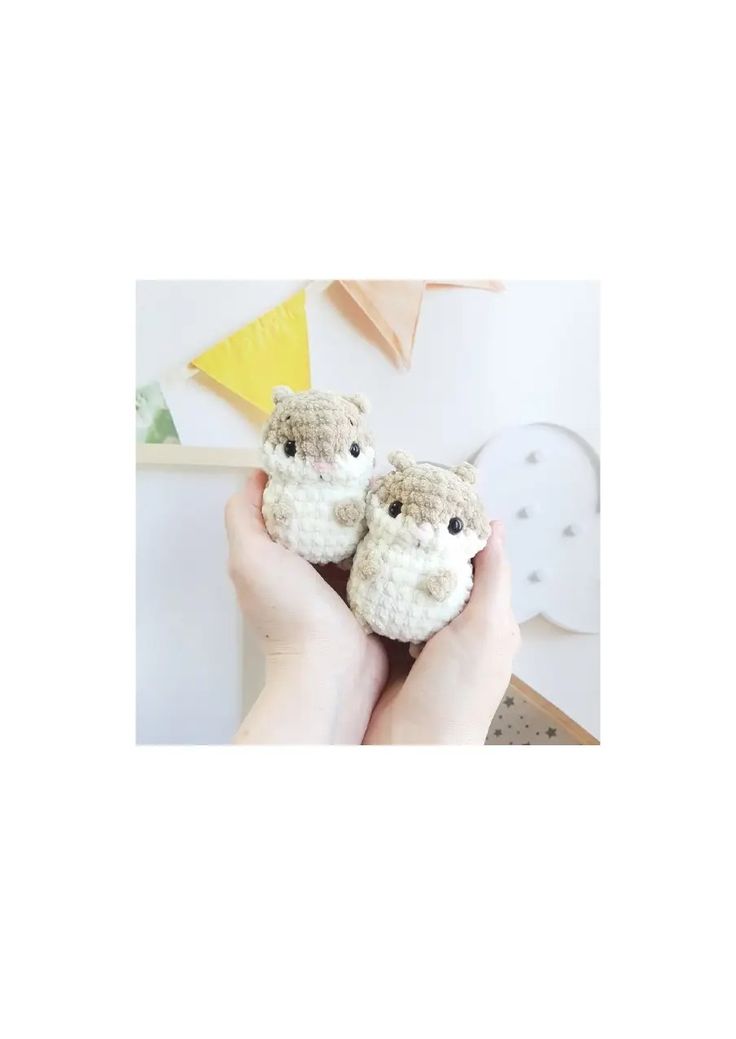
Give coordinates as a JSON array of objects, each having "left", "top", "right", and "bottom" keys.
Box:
[{"left": 364, "top": 522, "right": 521, "bottom": 744}]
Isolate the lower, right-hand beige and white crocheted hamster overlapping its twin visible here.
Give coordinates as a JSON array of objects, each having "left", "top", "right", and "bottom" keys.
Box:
[{"left": 347, "top": 451, "right": 491, "bottom": 648}]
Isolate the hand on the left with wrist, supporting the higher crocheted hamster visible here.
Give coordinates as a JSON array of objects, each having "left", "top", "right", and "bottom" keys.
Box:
[{"left": 226, "top": 470, "right": 388, "bottom": 743}]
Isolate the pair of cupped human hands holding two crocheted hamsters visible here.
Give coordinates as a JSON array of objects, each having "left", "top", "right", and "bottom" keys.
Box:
[{"left": 226, "top": 471, "right": 521, "bottom": 744}]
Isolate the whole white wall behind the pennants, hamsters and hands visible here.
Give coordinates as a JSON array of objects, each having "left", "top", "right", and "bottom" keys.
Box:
[{"left": 137, "top": 282, "right": 599, "bottom": 742}]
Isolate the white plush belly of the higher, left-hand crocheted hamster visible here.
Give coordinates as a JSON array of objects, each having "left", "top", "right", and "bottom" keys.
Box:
[{"left": 263, "top": 478, "right": 365, "bottom": 563}]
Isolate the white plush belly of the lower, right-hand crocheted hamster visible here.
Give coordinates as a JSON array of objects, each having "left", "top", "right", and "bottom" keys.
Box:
[{"left": 347, "top": 534, "right": 473, "bottom": 642}]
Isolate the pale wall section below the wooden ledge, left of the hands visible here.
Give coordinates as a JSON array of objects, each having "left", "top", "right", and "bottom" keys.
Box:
[{"left": 136, "top": 469, "right": 248, "bottom": 743}]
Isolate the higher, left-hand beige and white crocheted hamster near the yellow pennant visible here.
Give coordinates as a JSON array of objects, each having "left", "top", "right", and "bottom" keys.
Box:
[{"left": 263, "top": 387, "right": 375, "bottom": 563}]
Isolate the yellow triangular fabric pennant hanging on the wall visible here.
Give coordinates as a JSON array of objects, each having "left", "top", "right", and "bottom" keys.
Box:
[{"left": 191, "top": 289, "right": 310, "bottom": 415}]
